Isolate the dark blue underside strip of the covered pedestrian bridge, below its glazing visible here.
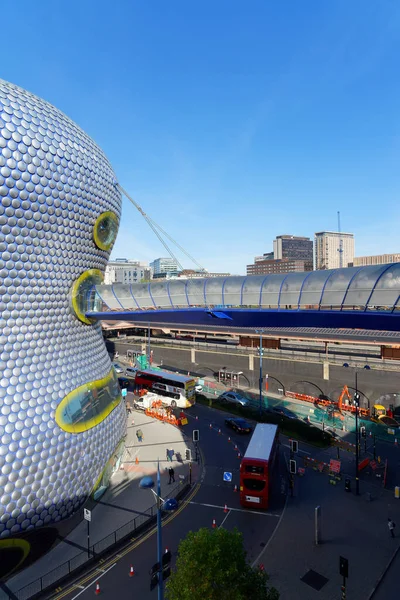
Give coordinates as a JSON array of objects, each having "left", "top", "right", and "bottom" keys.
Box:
[{"left": 86, "top": 308, "right": 400, "bottom": 331}]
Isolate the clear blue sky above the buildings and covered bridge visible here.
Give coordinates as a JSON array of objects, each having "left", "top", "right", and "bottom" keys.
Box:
[{"left": 0, "top": 0, "right": 400, "bottom": 274}]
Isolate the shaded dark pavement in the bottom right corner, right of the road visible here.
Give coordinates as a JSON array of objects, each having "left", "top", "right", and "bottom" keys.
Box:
[{"left": 260, "top": 469, "right": 400, "bottom": 600}]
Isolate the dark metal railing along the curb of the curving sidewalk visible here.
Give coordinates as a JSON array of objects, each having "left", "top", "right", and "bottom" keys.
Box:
[{"left": 10, "top": 477, "right": 190, "bottom": 600}]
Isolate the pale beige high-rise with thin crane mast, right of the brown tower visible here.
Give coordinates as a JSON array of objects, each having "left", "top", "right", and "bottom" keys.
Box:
[{"left": 314, "top": 231, "right": 354, "bottom": 270}]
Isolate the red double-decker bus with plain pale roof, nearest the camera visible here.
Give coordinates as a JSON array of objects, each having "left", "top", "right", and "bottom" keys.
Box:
[{"left": 240, "top": 423, "right": 278, "bottom": 508}]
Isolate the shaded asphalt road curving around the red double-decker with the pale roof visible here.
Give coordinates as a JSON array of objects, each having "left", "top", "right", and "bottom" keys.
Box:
[{"left": 52, "top": 405, "right": 287, "bottom": 600}]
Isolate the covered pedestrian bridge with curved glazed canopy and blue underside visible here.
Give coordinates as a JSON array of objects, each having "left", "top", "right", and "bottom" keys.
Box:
[{"left": 84, "top": 263, "right": 400, "bottom": 331}]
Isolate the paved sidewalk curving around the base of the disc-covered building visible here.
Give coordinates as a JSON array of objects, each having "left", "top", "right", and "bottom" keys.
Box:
[{"left": 4, "top": 394, "right": 197, "bottom": 598}]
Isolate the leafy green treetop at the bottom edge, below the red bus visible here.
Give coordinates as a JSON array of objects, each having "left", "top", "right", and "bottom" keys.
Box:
[{"left": 166, "top": 528, "right": 279, "bottom": 600}]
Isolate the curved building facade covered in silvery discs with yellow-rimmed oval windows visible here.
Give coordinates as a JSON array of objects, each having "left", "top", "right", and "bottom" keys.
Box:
[{"left": 0, "top": 80, "right": 126, "bottom": 538}]
